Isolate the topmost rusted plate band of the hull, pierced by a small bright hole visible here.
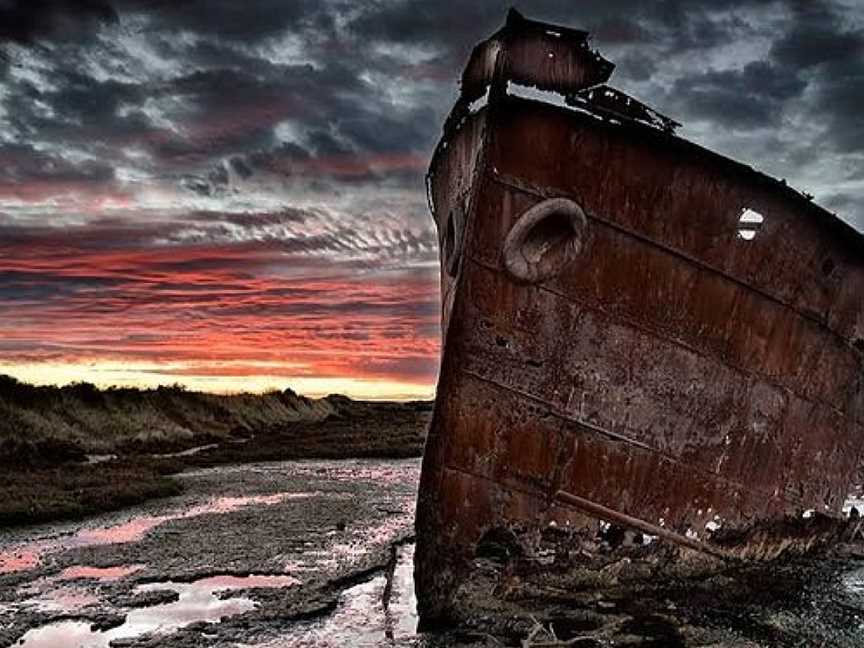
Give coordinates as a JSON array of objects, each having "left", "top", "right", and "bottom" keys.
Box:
[{"left": 490, "top": 98, "right": 864, "bottom": 340}]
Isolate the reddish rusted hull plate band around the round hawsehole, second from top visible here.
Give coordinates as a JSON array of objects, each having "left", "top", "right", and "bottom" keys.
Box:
[{"left": 467, "top": 177, "right": 861, "bottom": 410}]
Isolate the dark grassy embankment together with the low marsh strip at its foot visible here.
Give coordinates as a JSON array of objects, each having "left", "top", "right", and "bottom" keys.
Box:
[{"left": 0, "top": 376, "right": 431, "bottom": 527}]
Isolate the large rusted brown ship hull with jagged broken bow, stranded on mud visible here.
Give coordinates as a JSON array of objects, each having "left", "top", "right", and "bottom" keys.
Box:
[{"left": 416, "top": 14, "right": 864, "bottom": 621}]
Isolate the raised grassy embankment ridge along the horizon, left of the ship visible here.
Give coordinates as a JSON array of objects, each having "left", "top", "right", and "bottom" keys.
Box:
[{"left": 0, "top": 376, "right": 336, "bottom": 465}]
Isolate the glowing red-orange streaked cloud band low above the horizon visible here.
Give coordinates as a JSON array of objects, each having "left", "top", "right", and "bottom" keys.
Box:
[{"left": 0, "top": 234, "right": 439, "bottom": 386}]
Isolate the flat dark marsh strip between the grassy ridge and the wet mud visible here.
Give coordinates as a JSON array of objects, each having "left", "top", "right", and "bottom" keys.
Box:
[{"left": 0, "top": 397, "right": 432, "bottom": 529}]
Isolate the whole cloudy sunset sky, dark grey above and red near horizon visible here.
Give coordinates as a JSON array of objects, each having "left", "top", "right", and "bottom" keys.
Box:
[{"left": 0, "top": 0, "right": 864, "bottom": 398}]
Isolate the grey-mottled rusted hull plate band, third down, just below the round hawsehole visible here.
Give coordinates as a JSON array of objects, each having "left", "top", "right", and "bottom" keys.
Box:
[{"left": 451, "top": 258, "right": 860, "bottom": 509}]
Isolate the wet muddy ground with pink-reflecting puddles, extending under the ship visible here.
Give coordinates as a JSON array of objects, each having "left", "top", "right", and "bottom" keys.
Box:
[{"left": 0, "top": 459, "right": 864, "bottom": 648}]
